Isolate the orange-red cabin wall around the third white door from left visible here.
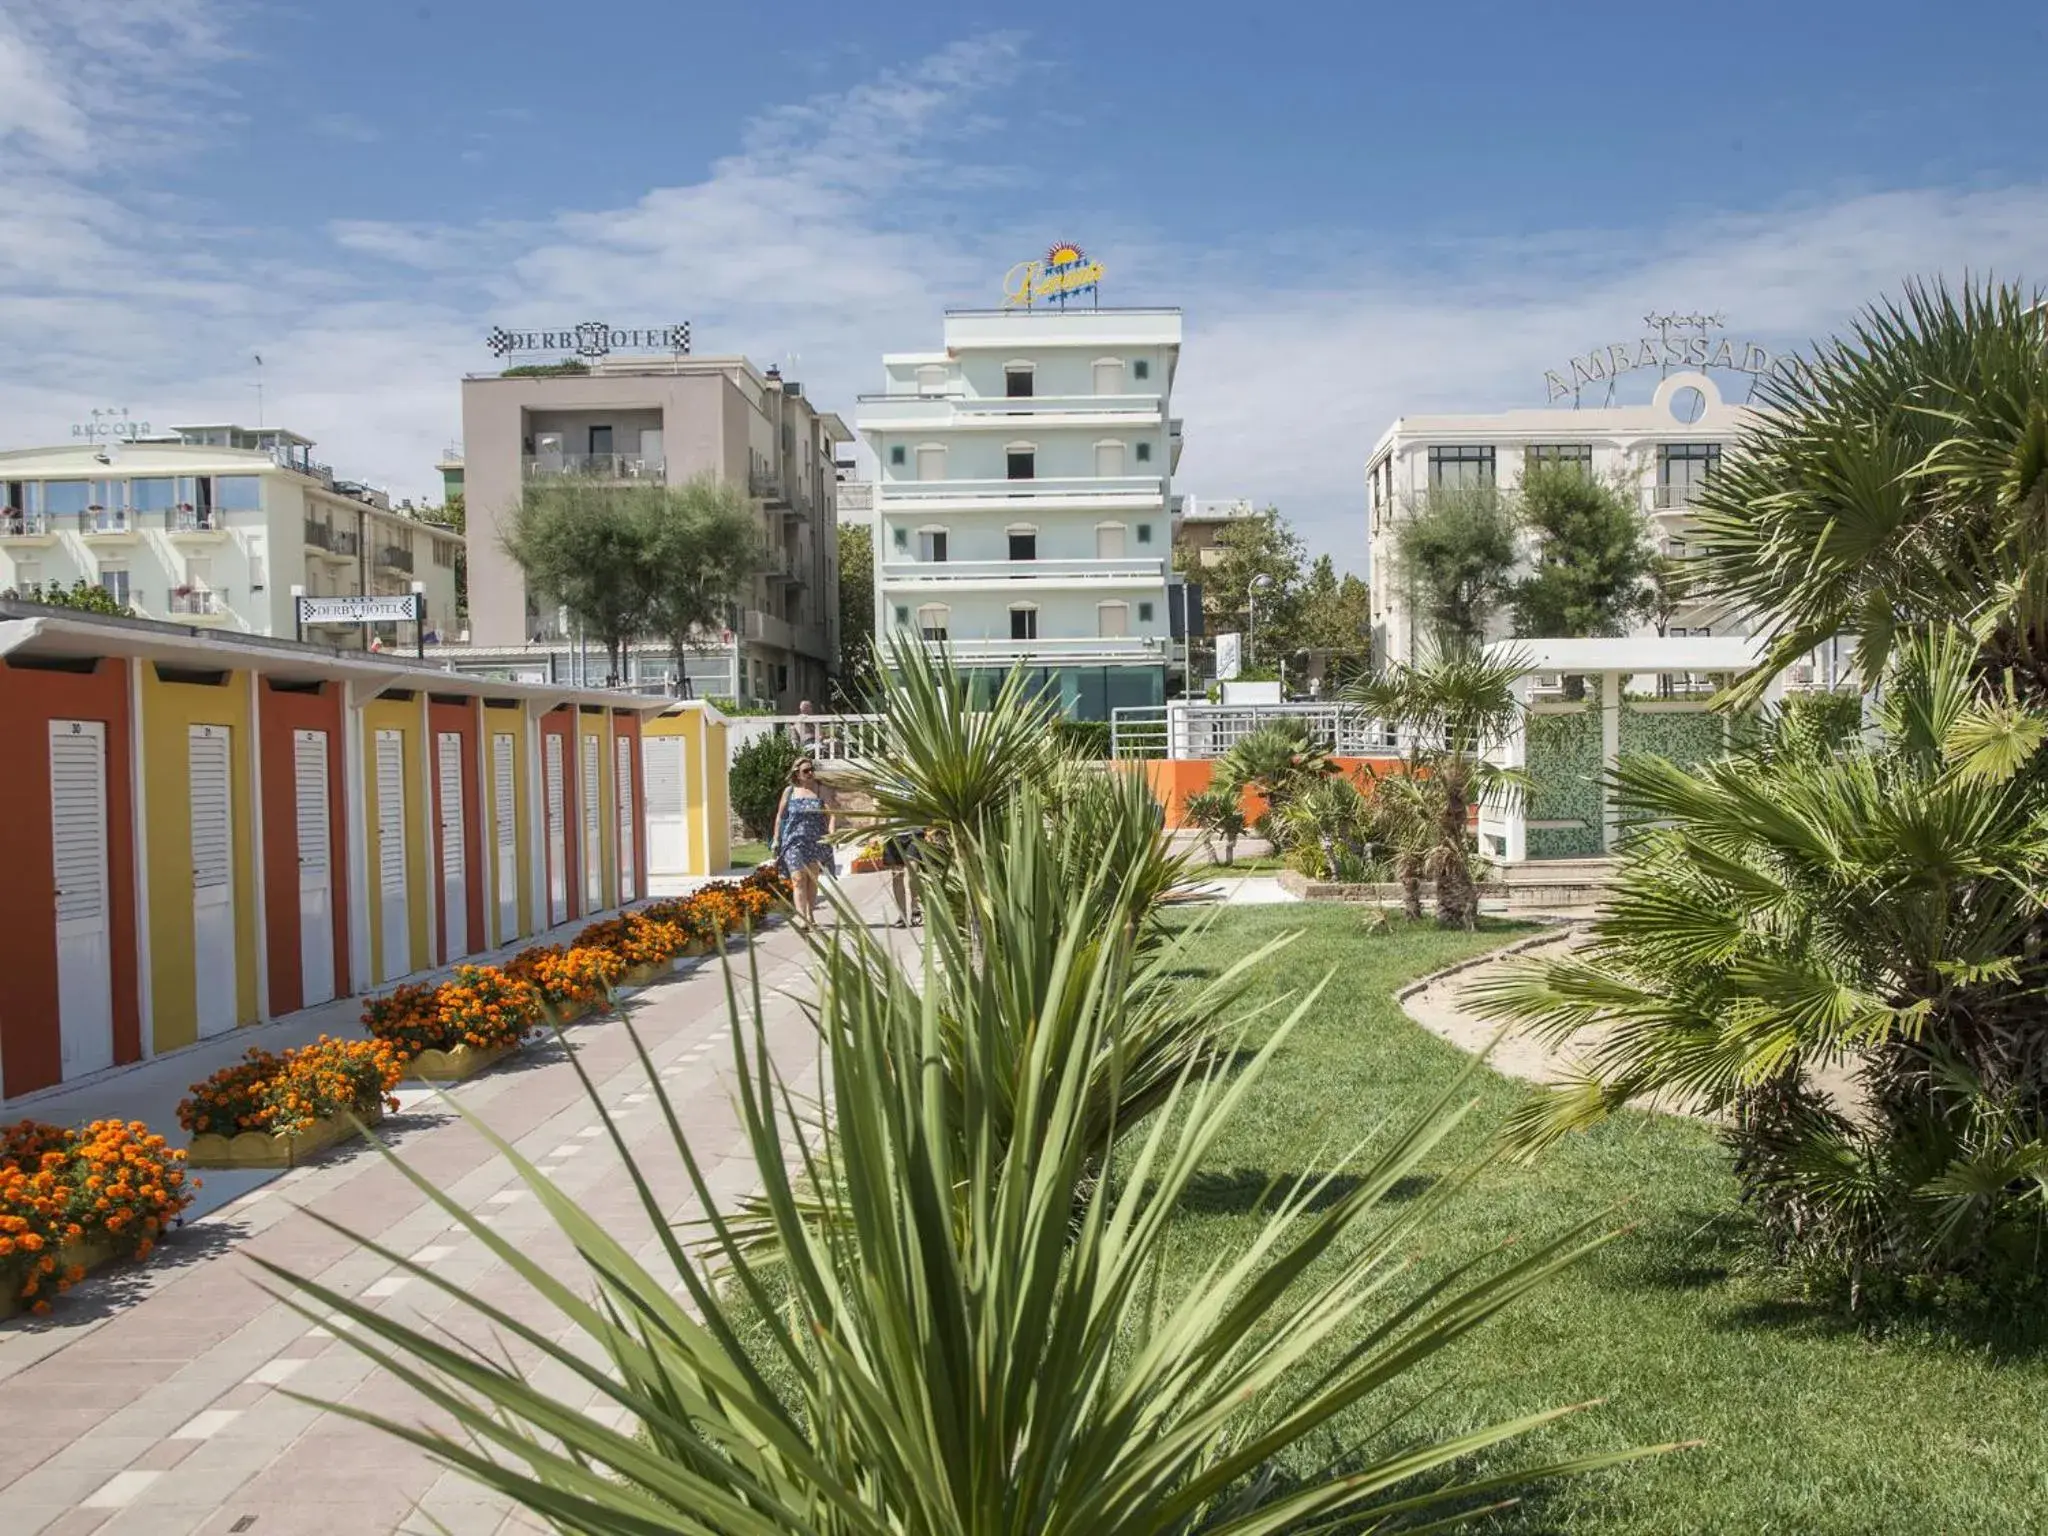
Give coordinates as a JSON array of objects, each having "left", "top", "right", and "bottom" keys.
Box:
[{"left": 256, "top": 680, "right": 354, "bottom": 1014}]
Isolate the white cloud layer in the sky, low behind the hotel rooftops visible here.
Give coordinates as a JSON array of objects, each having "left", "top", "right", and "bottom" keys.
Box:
[{"left": 0, "top": 0, "right": 2048, "bottom": 569}]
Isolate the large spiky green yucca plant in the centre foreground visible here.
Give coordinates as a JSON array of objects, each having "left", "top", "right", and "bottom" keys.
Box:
[{"left": 264, "top": 831, "right": 1671, "bottom": 1536}]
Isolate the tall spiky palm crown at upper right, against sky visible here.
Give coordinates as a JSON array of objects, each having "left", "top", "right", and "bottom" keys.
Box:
[{"left": 1694, "top": 285, "right": 2048, "bottom": 698}]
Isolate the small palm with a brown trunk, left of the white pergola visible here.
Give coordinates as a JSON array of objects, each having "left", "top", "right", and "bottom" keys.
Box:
[{"left": 1346, "top": 647, "right": 1528, "bottom": 928}]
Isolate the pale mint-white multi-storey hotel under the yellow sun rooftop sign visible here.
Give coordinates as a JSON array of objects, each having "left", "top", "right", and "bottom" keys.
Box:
[{"left": 858, "top": 305, "right": 1182, "bottom": 719}]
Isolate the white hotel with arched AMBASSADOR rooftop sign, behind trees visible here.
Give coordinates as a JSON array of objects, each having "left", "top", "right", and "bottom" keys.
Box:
[{"left": 1366, "top": 371, "right": 1833, "bottom": 671}]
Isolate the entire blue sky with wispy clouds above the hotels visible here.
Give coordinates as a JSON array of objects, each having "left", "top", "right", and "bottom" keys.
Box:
[{"left": 0, "top": 0, "right": 2048, "bottom": 569}]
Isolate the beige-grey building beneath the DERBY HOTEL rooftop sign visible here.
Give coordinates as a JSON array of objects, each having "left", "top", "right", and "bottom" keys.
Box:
[{"left": 458, "top": 354, "right": 852, "bottom": 709}]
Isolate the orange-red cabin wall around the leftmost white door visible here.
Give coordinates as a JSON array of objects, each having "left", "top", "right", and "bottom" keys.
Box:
[{"left": 0, "top": 657, "right": 141, "bottom": 1098}]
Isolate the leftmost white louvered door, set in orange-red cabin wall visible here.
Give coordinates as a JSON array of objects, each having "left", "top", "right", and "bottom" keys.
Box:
[{"left": 49, "top": 721, "right": 115, "bottom": 1077}]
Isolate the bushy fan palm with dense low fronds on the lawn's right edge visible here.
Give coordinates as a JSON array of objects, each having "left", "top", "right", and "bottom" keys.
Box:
[{"left": 1473, "top": 631, "right": 2048, "bottom": 1290}]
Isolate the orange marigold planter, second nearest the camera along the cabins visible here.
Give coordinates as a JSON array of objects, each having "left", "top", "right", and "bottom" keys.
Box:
[{"left": 178, "top": 1034, "right": 406, "bottom": 1167}]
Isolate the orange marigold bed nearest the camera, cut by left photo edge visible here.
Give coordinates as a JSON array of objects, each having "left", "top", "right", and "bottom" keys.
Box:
[{"left": 0, "top": 1120, "right": 197, "bottom": 1317}]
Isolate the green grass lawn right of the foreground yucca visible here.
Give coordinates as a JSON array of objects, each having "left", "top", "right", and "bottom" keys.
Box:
[{"left": 1176, "top": 905, "right": 2048, "bottom": 1536}]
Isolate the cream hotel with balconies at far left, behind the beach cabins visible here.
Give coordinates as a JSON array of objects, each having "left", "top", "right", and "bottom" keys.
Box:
[{"left": 0, "top": 424, "right": 463, "bottom": 647}]
